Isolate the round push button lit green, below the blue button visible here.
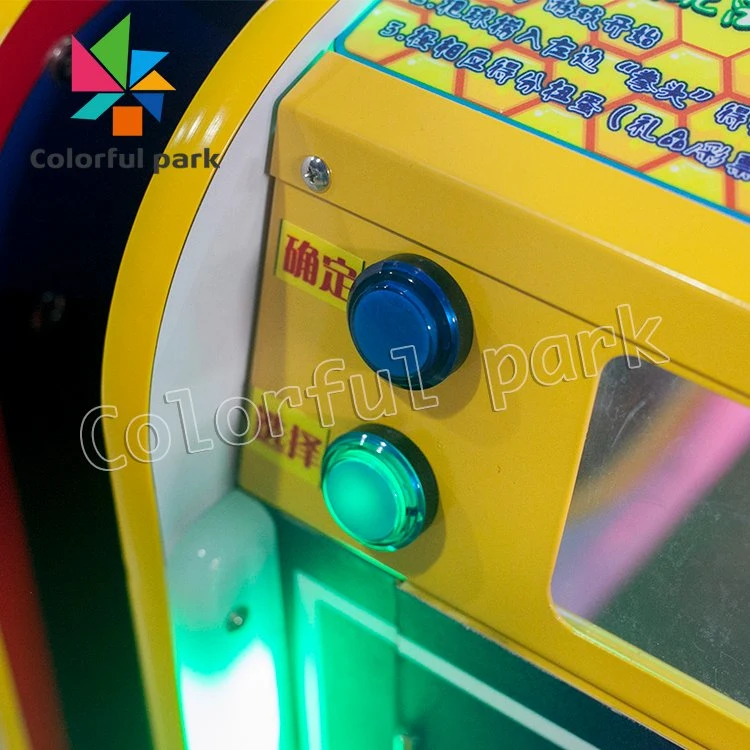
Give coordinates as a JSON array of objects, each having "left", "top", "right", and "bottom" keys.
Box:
[{"left": 322, "top": 425, "right": 438, "bottom": 550}]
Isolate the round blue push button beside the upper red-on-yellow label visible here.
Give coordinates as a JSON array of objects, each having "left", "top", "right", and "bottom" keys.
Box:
[{"left": 347, "top": 255, "right": 474, "bottom": 388}]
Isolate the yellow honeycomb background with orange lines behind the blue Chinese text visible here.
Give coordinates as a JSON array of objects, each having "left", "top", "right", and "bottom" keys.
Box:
[{"left": 337, "top": 0, "right": 750, "bottom": 219}]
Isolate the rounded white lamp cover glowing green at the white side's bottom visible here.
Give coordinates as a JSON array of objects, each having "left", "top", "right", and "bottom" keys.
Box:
[{"left": 167, "top": 491, "right": 290, "bottom": 750}]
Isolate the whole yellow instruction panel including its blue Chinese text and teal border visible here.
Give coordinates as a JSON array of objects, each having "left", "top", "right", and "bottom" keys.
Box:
[{"left": 336, "top": 0, "right": 750, "bottom": 221}]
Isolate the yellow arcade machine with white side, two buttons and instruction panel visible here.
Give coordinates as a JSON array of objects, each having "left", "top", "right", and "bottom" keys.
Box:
[{"left": 4, "top": 0, "right": 750, "bottom": 750}]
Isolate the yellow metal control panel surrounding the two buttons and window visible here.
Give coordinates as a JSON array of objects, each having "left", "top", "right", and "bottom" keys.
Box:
[{"left": 240, "top": 51, "right": 750, "bottom": 747}]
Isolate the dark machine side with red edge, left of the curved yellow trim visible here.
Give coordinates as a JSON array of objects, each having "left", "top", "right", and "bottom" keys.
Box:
[{"left": 0, "top": 0, "right": 260, "bottom": 750}]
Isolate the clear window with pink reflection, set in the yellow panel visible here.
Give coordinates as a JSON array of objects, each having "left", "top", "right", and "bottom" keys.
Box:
[{"left": 552, "top": 358, "right": 750, "bottom": 705}]
